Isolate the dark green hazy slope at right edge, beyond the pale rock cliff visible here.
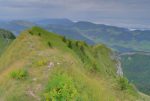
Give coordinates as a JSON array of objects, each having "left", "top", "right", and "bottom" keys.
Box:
[{"left": 122, "top": 53, "right": 150, "bottom": 94}]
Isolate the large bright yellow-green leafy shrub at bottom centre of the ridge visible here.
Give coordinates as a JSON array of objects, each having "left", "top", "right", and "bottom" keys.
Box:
[{"left": 44, "top": 74, "right": 78, "bottom": 101}]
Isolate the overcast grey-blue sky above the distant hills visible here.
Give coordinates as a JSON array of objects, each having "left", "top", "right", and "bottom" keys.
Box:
[{"left": 0, "top": 0, "right": 150, "bottom": 26}]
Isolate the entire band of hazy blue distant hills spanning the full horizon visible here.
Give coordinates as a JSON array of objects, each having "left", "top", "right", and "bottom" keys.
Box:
[{"left": 0, "top": 19, "right": 150, "bottom": 52}]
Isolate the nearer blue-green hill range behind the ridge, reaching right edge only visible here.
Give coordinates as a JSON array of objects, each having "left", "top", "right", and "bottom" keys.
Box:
[{"left": 45, "top": 21, "right": 150, "bottom": 52}]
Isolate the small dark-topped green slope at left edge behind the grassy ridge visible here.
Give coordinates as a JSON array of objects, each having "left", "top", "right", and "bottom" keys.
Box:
[{"left": 0, "top": 29, "right": 15, "bottom": 54}]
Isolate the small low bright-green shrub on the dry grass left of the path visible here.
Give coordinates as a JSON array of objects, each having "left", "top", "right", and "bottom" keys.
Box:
[{"left": 10, "top": 69, "right": 28, "bottom": 79}]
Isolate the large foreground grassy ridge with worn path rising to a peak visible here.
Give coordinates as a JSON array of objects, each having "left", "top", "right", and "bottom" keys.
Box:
[{"left": 0, "top": 27, "right": 148, "bottom": 101}]
